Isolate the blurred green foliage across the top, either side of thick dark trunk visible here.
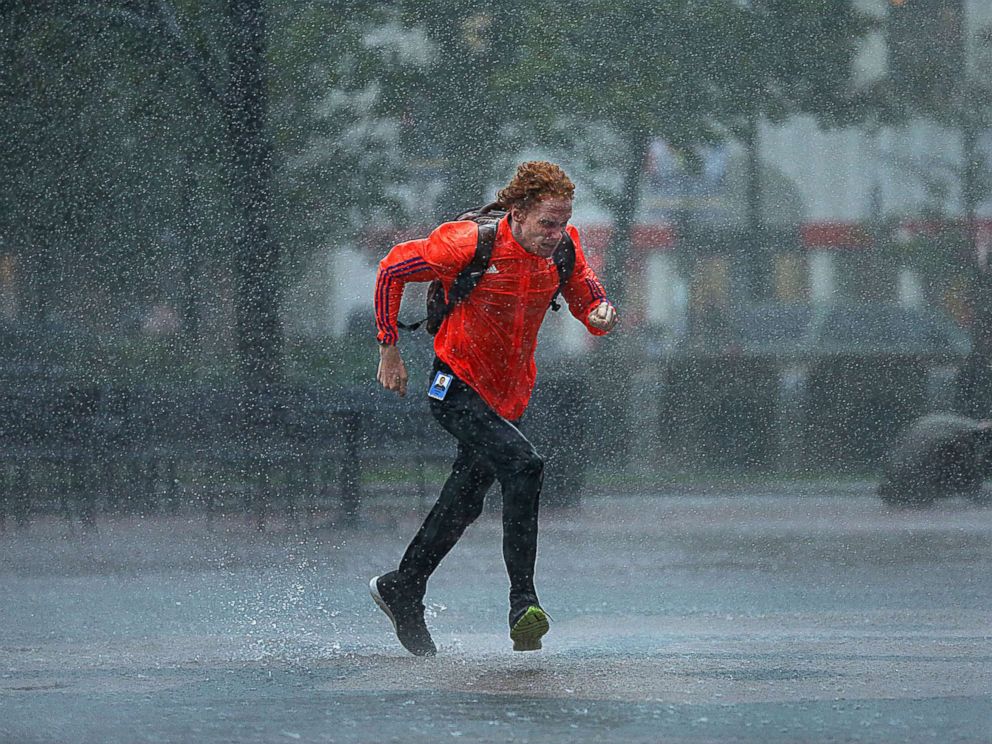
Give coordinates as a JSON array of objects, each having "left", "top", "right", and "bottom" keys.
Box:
[{"left": 0, "top": 0, "right": 876, "bottom": 378}]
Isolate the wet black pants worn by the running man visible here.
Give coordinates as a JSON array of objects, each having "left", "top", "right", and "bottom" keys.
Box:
[{"left": 399, "top": 361, "right": 544, "bottom": 607}]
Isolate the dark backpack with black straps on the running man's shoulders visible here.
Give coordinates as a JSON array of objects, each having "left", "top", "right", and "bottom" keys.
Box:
[{"left": 397, "top": 202, "right": 575, "bottom": 336}]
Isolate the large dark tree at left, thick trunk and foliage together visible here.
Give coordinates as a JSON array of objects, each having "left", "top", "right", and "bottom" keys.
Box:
[{"left": 0, "top": 0, "right": 410, "bottom": 385}]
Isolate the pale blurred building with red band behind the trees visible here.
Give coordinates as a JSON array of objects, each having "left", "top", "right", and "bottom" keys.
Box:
[{"left": 318, "top": 0, "right": 992, "bottom": 346}]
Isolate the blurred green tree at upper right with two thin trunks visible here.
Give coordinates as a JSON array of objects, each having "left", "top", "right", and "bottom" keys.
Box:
[{"left": 507, "top": 0, "right": 869, "bottom": 306}]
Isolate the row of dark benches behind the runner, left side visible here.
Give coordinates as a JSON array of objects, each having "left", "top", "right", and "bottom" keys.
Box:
[{"left": 0, "top": 380, "right": 453, "bottom": 527}]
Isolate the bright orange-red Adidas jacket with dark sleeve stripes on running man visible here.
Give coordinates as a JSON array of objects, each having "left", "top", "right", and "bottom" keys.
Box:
[{"left": 375, "top": 217, "right": 606, "bottom": 421}]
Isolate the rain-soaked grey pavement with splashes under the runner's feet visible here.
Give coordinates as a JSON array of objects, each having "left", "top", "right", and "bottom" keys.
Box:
[{"left": 0, "top": 485, "right": 992, "bottom": 744}]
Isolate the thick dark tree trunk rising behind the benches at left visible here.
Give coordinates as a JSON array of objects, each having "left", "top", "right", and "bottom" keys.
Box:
[{"left": 224, "top": 0, "right": 283, "bottom": 390}]
